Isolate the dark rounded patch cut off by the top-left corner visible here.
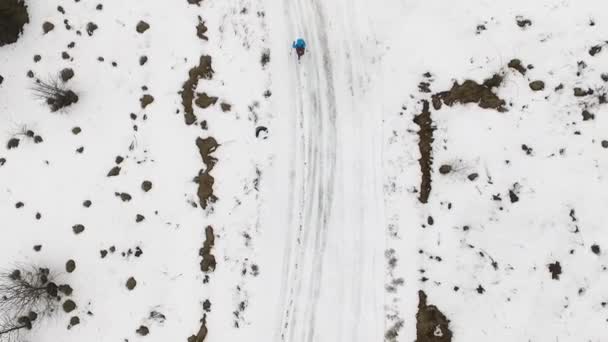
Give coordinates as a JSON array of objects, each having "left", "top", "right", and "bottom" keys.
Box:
[{"left": 0, "top": 0, "right": 30, "bottom": 46}]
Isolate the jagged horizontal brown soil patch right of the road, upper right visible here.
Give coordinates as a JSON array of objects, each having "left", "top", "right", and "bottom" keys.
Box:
[{"left": 432, "top": 74, "right": 507, "bottom": 112}]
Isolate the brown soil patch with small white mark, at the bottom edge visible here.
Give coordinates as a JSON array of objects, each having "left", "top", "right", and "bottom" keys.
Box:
[{"left": 416, "top": 291, "right": 452, "bottom": 342}]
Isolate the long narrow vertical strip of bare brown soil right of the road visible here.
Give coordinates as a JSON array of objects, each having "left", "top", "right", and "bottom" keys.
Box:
[{"left": 414, "top": 100, "right": 435, "bottom": 203}]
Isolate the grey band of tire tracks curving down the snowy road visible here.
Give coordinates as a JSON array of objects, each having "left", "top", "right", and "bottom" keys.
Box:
[{"left": 281, "top": 1, "right": 336, "bottom": 341}]
